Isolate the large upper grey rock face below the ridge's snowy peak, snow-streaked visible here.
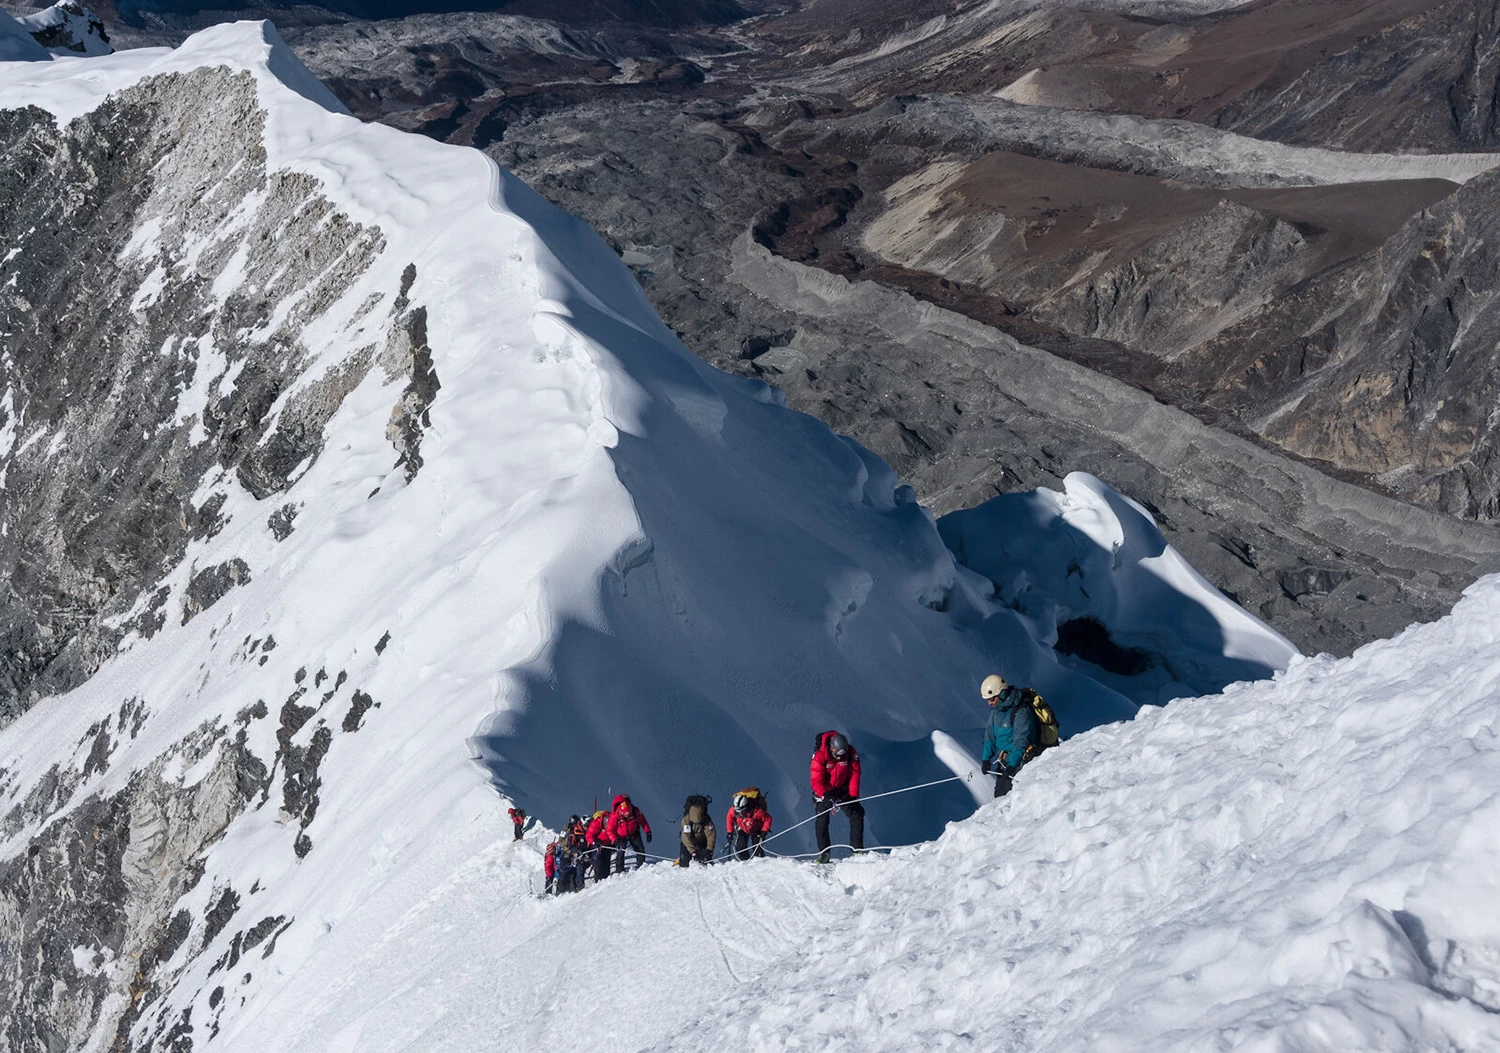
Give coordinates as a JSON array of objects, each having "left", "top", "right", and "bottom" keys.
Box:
[{"left": 0, "top": 74, "right": 417, "bottom": 719}]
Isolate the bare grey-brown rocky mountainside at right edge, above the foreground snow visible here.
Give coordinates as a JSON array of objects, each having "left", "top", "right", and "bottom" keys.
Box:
[{"left": 1184, "top": 165, "right": 1500, "bottom": 519}]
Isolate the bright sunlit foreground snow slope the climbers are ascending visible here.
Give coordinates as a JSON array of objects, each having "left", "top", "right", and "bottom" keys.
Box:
[{"left": 202, "top": 578, "right": 1500, "bottom": 1053}]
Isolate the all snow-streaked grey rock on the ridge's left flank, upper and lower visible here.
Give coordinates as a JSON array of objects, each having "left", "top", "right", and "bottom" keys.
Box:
[{"left": 0, "top": 55, "right": 432, "bottom": 1050}]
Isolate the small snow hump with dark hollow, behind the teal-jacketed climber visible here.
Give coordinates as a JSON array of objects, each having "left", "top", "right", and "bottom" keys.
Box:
[{"left": 939, "top": 473, "right": 1298, "bottom": 704}]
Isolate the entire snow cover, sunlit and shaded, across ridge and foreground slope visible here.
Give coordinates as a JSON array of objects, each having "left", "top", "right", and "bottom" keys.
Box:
[{"left": 0, "top": 23, "right": 1500, "bottom": 1053}]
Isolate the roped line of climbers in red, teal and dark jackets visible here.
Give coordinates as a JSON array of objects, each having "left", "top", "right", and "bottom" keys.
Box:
[{"left": 534, "top": 674, "right": 1058, "bottom": 893}]
